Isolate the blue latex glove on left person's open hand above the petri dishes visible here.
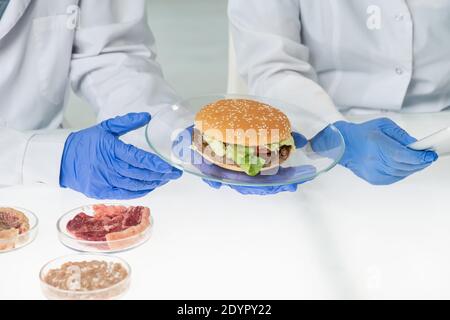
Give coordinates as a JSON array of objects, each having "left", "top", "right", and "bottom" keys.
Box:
[{"left": 60, "top": 113, "right": 182, "bottom": 199}]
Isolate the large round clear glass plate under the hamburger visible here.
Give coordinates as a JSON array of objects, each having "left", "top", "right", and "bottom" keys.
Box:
[{"left": 146, "top": 94, "right": 345, "bottom": 186}]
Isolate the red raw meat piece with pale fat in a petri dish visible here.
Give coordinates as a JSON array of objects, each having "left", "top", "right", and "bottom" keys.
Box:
[{"left": 66, "top": 205, "right": 151, "bottom": 249}]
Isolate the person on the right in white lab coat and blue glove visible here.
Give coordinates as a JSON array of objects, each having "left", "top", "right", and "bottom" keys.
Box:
[{"left": 218, "top": 0, "right": 442, "bottom": 194}]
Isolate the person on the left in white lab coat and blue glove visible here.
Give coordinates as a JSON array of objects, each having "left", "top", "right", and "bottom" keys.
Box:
[{"left": 0, "top": 0, "right": 181, "bottom": 199}]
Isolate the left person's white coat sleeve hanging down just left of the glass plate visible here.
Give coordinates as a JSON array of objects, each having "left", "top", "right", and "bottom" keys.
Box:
[{"left": 70, "top": 0, "right": 178, "bottom": 121}]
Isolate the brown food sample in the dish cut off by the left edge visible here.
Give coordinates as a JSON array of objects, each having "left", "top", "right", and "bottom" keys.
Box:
[{"left": 0, "top": 208, "right": 30, "bottom": 251}]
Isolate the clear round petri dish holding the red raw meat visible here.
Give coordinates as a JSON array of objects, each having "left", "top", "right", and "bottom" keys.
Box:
[{"left": 57, "top": 203, "right": 153, "bottom": 253}]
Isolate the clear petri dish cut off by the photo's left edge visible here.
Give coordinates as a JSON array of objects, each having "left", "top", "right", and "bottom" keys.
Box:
[{"left": 0, "top": 206, "right": 39, "bottom": 254}]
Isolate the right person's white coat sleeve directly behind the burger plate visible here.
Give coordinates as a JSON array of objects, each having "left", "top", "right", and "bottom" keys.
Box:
[{"left": 228, "top": 0, "right": 344, "bottom": 123}]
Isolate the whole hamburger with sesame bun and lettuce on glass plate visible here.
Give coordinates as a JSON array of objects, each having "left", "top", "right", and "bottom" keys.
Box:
[{"left": 192, "top": 99, "right": 295, "bottom": 176}]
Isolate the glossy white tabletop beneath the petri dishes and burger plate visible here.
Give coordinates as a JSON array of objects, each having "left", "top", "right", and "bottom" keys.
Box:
[{"left": 0, "top": 113, "right": 450, "bottom": 299}]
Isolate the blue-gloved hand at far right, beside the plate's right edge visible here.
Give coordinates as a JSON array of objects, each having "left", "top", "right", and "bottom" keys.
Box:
[{"left": 330, "top": 118, "right": 438, "bottom": 185}]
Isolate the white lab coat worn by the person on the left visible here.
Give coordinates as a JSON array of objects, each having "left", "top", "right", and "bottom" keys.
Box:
[{"left": 0, "top": 0, "right": 176, "bottom": 185}]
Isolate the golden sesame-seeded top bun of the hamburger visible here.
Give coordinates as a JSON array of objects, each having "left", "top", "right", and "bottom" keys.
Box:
[{"left": 195, "top": 99, "right": 292, "bottom": 147}]
